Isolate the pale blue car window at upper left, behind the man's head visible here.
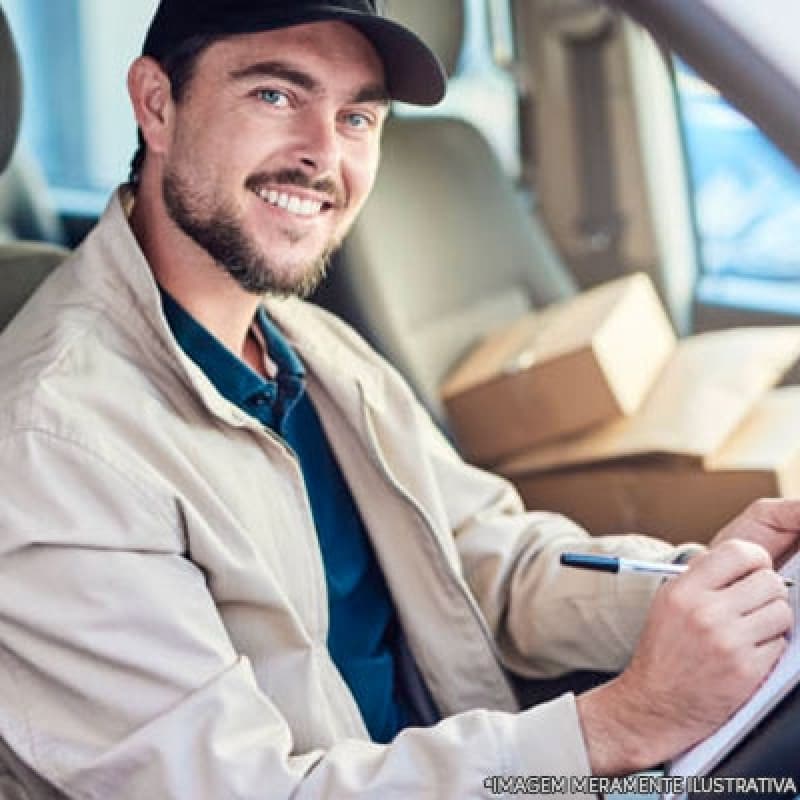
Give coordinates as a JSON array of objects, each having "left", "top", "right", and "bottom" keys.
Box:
[{"left": 3, "top": 0, "right": 156, "bottom": 212}]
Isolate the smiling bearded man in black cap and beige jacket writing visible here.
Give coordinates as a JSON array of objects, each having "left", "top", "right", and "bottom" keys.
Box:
[{"left": 0, "top": 0, "right": 800, "bottom": 800}]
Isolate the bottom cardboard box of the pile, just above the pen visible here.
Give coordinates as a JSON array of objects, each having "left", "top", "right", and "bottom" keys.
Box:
[{"left": 504, "top": 387, "right": 800, "bottom": 543}]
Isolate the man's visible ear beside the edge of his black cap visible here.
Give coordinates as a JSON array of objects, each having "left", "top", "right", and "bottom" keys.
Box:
[{"left": 128, "top": 56, "right": 174, "bottom": 153}]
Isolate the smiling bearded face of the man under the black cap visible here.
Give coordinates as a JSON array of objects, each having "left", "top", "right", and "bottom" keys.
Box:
[{"left": 157, "top": 22, "right": 388, "bottom": 294}]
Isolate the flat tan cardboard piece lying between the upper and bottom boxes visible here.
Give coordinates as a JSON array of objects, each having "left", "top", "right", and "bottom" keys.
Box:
[{"left": 498, "top": 326, "right": 800, "bottom": 475}]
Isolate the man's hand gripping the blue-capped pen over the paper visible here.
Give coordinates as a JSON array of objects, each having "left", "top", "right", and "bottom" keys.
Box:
[{"left": 577, "top": 536, "right": 800, "bottom": 775}]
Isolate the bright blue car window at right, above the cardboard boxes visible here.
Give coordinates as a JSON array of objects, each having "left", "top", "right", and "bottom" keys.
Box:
[{"left": 676, "top": 62, "right": 800, "bottom": 312}]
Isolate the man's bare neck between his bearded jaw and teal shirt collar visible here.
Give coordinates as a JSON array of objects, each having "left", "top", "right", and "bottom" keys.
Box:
[{"left": 129, "top": 186, "right": 261, "bottom": 358}]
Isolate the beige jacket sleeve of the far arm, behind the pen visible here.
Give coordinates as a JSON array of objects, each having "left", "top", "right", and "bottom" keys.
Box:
[{"left": 420, "top": 400, "right": 702, "bottom": 678}]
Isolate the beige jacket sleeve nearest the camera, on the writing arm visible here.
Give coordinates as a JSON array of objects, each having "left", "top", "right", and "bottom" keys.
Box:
[{"left": 0, "top": 430, "right": 600, "bottom": 800}]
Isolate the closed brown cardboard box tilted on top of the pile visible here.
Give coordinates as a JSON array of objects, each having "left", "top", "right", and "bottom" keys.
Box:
[{"left": 441, "top": 274, "right": 675, "bottom": 464}]
